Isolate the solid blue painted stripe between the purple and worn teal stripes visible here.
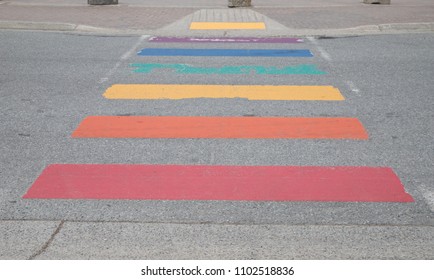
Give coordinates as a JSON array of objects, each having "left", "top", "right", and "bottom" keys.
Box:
[{"left": 138, "top": 49, "right": 313, "bottom": 57}]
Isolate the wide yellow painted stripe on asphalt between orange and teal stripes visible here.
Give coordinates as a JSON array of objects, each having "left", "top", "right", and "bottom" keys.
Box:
[{"left": 104, "top": 84, "right": 344, "bottom": 100}]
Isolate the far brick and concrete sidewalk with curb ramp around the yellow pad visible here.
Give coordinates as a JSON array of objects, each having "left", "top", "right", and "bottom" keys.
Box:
[{"left": 0, "top": 0, "right": 434, "bottom": 36}]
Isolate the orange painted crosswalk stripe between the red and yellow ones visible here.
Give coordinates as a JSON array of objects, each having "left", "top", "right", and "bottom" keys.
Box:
[{"left": 72, "top": 116, "right": 368, "bottom": 139}]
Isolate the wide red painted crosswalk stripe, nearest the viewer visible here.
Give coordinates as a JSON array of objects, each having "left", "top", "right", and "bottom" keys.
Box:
[{"left": 24, "top": 164, "right": 413, "bottom": 202}]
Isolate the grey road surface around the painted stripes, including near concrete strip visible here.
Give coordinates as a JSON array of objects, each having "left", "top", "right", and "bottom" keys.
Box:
[{"left": 0, "top": 31, "right": 434, "bottom": 259}]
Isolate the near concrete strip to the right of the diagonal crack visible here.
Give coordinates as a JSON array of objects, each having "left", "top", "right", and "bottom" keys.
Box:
[{"left": 26, "top": 222, "right": 434, "bottom": 260}]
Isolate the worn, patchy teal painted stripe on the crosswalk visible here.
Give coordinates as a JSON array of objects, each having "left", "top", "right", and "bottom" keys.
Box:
[{"left": 130, "top": 63, "right": 326, "bottom": 75}]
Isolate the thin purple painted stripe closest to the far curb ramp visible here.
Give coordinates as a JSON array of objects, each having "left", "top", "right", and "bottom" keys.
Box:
[{"left": 149, "top": 37, "right": 303, "bottom": 43}]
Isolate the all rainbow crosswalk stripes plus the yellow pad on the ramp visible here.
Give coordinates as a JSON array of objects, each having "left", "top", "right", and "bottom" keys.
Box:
[{"left": 24, "top": 22, "right": 413, "bottom": 202}]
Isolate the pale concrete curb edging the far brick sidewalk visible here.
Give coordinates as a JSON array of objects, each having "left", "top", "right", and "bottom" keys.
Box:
[{"left": 0, "top": 21, "right": 434, "bottom": 37}]
